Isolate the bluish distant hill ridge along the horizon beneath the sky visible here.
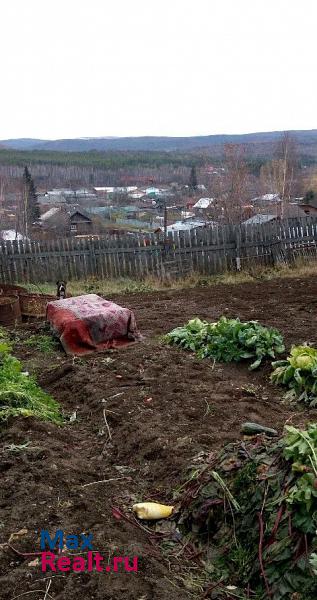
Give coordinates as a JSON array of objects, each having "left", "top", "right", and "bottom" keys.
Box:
[{"left": 0, "top": 129, "right": 317, "bottom": 156}]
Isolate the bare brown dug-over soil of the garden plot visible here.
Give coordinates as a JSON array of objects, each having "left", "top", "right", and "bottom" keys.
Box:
[{"left": 0, "top": 277, "right": 317, "bottom": 600}]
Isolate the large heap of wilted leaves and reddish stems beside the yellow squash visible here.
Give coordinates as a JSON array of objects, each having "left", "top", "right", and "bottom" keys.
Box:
[{"left": 176, "top": 424, "right": 317, "bottom": 600}]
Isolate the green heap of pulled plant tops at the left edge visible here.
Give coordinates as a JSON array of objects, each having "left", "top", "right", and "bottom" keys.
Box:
[{"left": 0, "top": 330, "right": 63, "bottom": 423}]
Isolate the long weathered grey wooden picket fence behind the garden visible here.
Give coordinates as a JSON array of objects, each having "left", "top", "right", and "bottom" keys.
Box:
[{"left": 0, "top": 217, "right": 317, "bottom": 283}]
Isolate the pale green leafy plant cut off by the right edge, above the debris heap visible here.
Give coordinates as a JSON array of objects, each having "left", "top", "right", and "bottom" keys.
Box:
[{"left": 271, "top": 346, "right": 317, "bottom": 406}]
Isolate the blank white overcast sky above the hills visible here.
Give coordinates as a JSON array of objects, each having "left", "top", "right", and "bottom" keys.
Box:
[{"left": 0, "top": 0, "right": 317, "bottom": 139}]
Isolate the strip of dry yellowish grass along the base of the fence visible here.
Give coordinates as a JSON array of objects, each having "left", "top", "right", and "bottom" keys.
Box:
[{"left": 19, "top": 260, "right": 317, "bottom": 296}]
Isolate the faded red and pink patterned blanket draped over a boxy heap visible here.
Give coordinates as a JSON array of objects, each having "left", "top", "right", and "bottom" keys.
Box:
[{"left": 46, "top": 294, "right": 141, "bottom": 355}]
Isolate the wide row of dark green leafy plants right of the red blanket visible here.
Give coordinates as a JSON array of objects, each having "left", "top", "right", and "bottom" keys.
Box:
[{"left": 164, "top": 317, "right": 285, "bottom": 369}]
